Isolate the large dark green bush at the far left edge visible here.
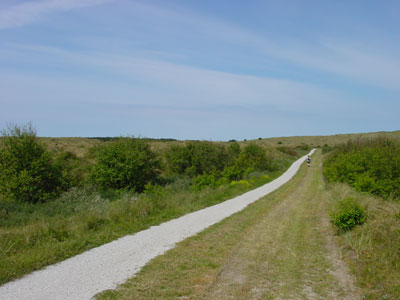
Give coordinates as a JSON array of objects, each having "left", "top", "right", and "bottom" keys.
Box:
[{"left": 0, "top": 125, "right": 68, "bottom": 203}]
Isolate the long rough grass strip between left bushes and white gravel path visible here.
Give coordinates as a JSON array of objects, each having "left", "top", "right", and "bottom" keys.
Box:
[{"left": 0, "top": 154, "right": 302, "bottom": 284}]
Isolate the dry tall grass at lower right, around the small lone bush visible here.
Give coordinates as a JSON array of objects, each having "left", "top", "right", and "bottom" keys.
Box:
[{"left": 329, "top": 184, "right": 400, "bottom": 300}]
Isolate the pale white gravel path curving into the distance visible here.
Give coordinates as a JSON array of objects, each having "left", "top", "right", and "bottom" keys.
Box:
[{"left": 0, "top": 150, "right": 314, "bottom": 300}]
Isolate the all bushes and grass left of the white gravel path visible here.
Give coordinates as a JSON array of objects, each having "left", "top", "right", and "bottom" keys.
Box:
[{"left": 0, "top": 126, "right": 300, "bottom": 284}]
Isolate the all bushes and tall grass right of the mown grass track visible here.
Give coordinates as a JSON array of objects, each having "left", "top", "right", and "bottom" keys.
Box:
[{"left": 324, "top": 137, "right": 400, "bottom": 299}]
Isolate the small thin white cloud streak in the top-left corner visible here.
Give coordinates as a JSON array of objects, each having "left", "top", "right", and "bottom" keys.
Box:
[{"left": 0, "top": 0, "right": 108, "bottom": 29}]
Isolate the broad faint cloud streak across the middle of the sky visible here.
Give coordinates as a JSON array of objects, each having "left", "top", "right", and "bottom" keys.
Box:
[{"left": 1, "top": 41, "right": 339, "bottom": 112}]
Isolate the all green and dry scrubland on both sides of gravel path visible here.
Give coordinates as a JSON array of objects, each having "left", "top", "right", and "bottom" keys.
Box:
[{"left": 0, "top": 127, "right": 400, "bottom": 299}]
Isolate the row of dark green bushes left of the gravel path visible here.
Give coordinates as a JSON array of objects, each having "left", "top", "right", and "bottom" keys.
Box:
[{"left": 0, "top": 125, "right": 282, "bottom": 203}]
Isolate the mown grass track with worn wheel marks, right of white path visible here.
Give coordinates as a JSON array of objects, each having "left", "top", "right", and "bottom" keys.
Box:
[{"left": 97, "top": 151, "right": 357, "bottom": 300}]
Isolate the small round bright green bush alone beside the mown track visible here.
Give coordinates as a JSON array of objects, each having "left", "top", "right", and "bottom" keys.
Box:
[{"left": 332, "top": 198, "right": 366, "bottom": 231}]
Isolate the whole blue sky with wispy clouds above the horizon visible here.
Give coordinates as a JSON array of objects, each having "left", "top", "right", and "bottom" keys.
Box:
[{"left": 0, "top": 0, "right": 400, "bottom": 140}]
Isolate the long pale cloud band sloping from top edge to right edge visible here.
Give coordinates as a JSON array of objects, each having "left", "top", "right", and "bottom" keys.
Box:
[{"left": 122, "top": 2, "right": 400, "bottom": 90}]
